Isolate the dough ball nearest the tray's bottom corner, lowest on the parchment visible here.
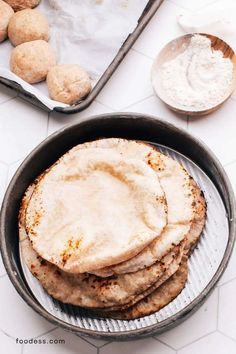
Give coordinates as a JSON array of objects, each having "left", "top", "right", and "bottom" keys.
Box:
[{"left": 47, "top": 64, "right": 91, "bottom": 105}]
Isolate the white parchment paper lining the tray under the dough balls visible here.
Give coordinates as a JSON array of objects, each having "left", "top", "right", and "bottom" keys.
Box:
[{"left": 0, "top": 0, "right": 148, "bottom": 109}]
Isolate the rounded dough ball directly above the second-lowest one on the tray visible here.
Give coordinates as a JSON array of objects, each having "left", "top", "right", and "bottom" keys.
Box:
[{"left": 8, "top": 9, "right": 49, "bottom": 45}]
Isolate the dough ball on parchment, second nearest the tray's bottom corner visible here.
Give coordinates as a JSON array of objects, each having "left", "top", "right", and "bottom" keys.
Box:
[{"left": 10, "top": 40, "right": 56, "bottom": 84}]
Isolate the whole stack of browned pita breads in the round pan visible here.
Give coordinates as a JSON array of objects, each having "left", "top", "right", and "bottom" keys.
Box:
[{"left": 19, "top": 138, "right": 206, "bottom": 319}]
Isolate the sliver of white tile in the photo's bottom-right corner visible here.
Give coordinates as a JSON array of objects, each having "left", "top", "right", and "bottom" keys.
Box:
[{"left": 178, "top": 332, "right": 236, "bottom": 354}]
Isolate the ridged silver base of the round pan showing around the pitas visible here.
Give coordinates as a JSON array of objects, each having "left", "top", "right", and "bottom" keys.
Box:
[{"left": 18, "top": 144, "right": 229, "bottom": 334}]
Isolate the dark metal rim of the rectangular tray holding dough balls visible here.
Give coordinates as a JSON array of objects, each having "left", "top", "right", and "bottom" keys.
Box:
[{"left": 0, "top": 0, "right": 164, "bottom": 114}]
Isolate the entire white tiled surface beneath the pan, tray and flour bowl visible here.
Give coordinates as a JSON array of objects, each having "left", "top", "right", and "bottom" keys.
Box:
[{"left": 0, "top": 0, "right": 236, "bottom": 354}]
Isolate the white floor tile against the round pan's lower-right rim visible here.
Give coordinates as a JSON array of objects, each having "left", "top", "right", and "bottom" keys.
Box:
[{"left": 157, "top": 290, "right": 218, "bottom": 349}]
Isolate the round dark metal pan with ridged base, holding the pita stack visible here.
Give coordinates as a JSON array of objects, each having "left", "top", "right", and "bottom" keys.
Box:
[{"left": 0, "top": 113, "right": 236, "bottom": 340}]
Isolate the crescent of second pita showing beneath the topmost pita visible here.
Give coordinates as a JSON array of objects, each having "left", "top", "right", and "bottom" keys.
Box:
[{"left": 75, "top": 138, "right": 195, "bottom": 277}]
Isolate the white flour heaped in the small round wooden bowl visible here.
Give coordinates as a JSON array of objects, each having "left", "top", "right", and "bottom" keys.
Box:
[{"left": 161, "top": 35, "right": 233, "bottom": 110}]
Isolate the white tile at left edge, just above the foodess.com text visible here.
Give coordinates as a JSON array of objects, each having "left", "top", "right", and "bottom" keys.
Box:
[{"left": 0, "top": 276, "right": 55, "bottom": 339}]
